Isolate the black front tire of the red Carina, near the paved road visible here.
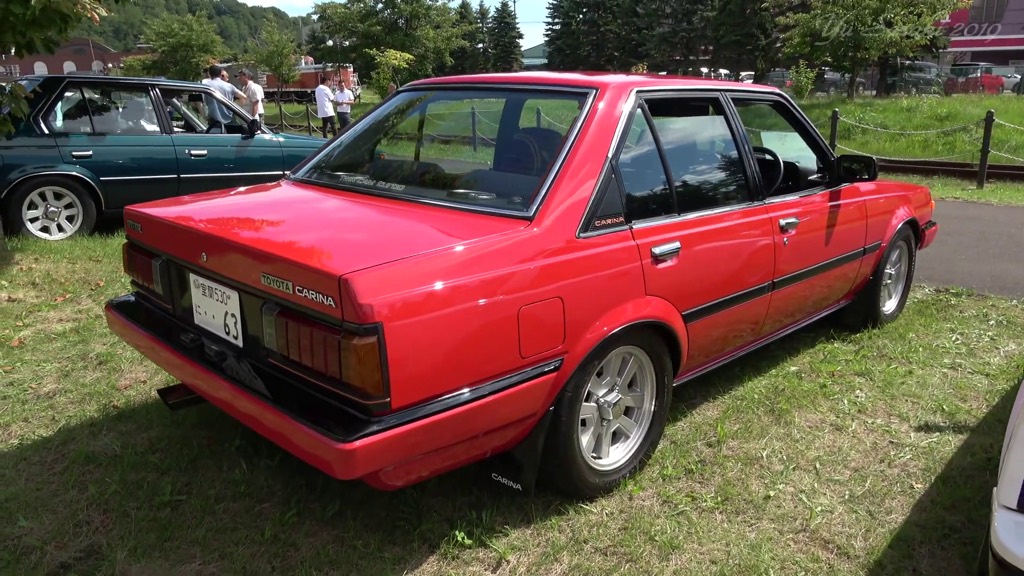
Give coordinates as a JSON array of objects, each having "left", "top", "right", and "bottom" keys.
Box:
[{"left": 842, "top": 224, "right": 918, "bottom": 330}]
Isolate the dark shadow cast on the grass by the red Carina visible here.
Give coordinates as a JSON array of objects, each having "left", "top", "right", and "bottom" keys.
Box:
[{"left": 0, "top": 315, "right": 856, "bottom": 575}]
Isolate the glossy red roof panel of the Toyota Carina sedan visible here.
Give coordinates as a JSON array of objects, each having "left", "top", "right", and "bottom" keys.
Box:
[{"left": 407, "top": 72, "right": 778, "bottom": 91}]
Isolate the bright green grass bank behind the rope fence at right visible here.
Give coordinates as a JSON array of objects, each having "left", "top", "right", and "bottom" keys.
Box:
[{"left": 800, "top": 95, "right": 1024, "bottom": 164}]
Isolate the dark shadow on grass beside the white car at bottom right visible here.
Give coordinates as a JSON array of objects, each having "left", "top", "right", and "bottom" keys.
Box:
[{"left": 867, "top": 368, "right": 1020, "bottom": 576}]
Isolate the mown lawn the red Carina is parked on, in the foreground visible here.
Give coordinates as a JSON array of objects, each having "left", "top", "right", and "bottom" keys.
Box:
[{"left": 0, "top": 236, "right": 1024, "bottom": 576}]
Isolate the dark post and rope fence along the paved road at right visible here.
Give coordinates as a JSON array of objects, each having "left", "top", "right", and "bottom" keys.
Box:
[{"left": 828, "top": 109, "right": 1024, "bottom": 189}]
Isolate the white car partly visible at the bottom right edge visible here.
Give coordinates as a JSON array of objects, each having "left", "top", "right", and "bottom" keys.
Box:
[{"left": 978, "top": 379, "right": 1024, "bottom": 576}]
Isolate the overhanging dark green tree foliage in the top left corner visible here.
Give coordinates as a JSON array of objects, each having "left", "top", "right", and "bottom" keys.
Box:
[{"left": 0, "top": 0, "right": 120, "bottom": 135}]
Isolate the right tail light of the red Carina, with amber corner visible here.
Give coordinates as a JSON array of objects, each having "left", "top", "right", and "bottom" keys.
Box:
[{"left": 263, "top": 302, "right": 388, "bottom": 404}]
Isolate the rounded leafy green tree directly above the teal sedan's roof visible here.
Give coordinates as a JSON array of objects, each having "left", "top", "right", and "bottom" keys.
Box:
[{"left": 143, "top": 13, "right": 227, "bottom": 80}]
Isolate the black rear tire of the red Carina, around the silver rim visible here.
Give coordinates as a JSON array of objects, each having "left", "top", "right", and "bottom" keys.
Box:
[{"left": 541, "top": 329, "right": 673, "bottom": 499}]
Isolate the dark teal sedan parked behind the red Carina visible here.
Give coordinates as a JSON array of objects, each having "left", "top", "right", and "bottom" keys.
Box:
[{"left": 0, "top": 75, "right": 325, "bottom": 240}]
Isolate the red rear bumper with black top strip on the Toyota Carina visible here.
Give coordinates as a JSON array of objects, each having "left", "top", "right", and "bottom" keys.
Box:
[{"left": 104, "top": 295, "right": 561, "bottom": 489}]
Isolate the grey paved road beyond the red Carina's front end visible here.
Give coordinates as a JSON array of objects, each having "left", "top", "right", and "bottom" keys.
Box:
[{"left": 914, "top": 200, "right": 1024, "bottom": 298}]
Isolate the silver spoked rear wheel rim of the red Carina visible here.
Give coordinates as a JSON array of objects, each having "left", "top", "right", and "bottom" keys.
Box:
[{"left": 579, "top": 345, "right": 657, "bottom": 471}]
